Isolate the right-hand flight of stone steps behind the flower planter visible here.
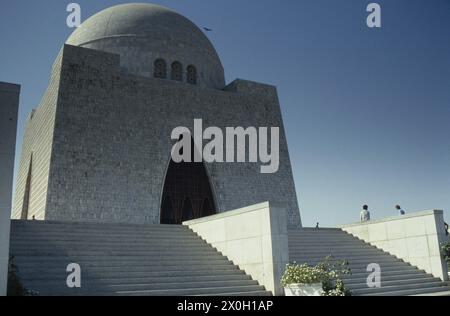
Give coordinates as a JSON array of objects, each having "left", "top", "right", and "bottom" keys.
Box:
[{"left": 289, "top": 228, "right": 450, "bottom": 296}]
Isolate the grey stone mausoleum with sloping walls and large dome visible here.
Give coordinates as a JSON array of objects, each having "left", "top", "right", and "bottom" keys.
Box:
[{"left": 13, "top": 4, "right": 301, "bottom": 227}]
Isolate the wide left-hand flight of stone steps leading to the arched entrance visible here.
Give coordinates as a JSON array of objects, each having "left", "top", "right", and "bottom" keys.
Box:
[{"left": 10, "top": 221, "right": 270, "bottom": 296}]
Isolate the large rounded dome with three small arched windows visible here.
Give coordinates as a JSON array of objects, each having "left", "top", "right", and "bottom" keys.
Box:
[{"left": 66, "top": 3, "right": 225, "bottom": 89}]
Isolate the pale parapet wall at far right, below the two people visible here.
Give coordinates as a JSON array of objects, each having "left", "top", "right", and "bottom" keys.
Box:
[{"left": 341, "top": 210, "right": 448, "bottom": 281}]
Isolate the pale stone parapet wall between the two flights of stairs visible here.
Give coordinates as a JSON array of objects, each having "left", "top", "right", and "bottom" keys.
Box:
[{"left": 183, "top": 202, "right": 289, "bottom": 295}]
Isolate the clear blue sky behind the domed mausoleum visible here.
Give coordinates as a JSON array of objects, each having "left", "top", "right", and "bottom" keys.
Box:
[{"left": 0, "top": 0, "right": 450, "bottom": 226}]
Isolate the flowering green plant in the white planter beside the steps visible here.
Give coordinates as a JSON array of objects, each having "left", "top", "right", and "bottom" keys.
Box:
[{"left": 281, "top": 256, "right": 351, "bottom": 296}]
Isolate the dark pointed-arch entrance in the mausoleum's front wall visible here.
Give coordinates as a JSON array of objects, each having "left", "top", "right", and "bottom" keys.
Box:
[{"left": 161, "top": 154, "right": 216, "bottom": 225}]
